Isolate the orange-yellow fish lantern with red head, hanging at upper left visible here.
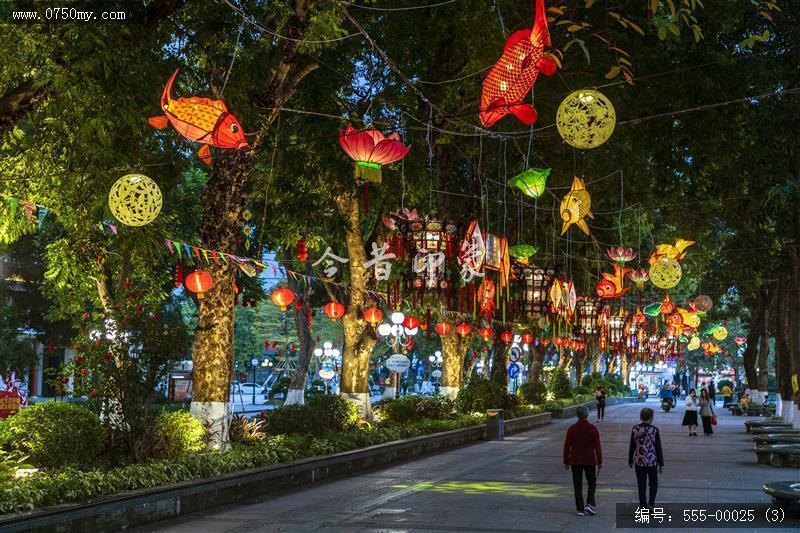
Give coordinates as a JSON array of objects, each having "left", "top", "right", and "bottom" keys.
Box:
[{"left": 147, "top": 69, "right": 249, "bottom": 165}]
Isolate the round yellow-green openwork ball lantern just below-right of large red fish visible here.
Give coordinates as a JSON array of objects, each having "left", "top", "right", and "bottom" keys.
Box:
[{"left": 556, "top": 89, "right": 617, "bottom": 150}]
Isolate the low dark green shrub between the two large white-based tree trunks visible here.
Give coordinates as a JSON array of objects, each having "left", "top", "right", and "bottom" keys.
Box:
[{"left": 261, "top": 394, "right": 358, "bottom": 435}]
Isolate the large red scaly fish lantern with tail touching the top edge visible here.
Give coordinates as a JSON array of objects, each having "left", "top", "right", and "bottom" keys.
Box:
[{"left": 480, "top": 0, "right": 556, "bottom": 127}]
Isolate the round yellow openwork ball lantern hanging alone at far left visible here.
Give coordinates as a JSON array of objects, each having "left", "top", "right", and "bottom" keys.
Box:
[{"left": 108, "top": 174, "right": 162, "bottom": 226}]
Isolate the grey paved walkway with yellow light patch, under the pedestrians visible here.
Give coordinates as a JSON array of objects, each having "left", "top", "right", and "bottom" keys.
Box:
[{"left": 141, "top": 401, "right": 800, "bottom": 533}]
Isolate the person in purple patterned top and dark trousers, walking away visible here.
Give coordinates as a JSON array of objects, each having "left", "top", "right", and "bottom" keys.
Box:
[{"left": 628, "top": 407, "right": 664, "bottom": 509}]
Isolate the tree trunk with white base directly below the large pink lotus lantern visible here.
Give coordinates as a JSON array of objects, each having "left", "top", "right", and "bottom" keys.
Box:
[{"left": 335, "top": 192, "right": 376, "bottom": 420}]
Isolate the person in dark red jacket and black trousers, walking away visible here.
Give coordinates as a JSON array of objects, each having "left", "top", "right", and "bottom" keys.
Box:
[{"left": 564, "top": 405, "right": 603, "bottom": 516}]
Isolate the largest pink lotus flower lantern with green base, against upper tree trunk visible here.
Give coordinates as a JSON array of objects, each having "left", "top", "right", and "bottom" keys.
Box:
[{"left": 339, "top": 126, "right": 411, "bottom": 183}]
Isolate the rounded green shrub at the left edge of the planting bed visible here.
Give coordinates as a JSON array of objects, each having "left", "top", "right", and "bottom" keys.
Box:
[{"left": 4, "top": 402, "right": 105, "bottom": 468}]
